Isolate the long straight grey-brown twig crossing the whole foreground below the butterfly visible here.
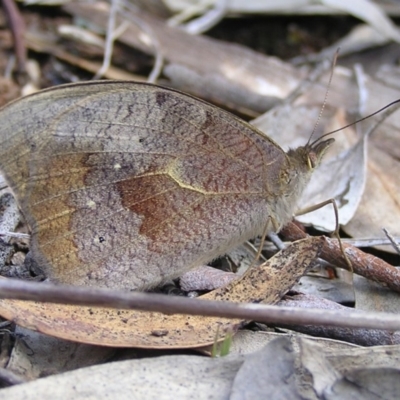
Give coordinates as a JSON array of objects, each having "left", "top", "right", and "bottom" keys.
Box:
[{"left": 0, "top": 279, "right": 400, "bottom": 331}]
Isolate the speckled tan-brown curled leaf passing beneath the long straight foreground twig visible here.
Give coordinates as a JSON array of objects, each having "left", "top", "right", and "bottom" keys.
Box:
[{"left": 0, "top": 238, "right": 323, "bottom": 348}]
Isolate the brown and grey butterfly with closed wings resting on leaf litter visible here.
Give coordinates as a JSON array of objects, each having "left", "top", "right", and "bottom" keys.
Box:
[{"left": 0, "top": 81, "right": 333, "bottom": 289}]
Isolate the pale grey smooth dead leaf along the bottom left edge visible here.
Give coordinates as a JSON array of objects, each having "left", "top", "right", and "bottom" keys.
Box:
[{"left": 1, "top": 356, "right": 244, "bottom": 400}]
